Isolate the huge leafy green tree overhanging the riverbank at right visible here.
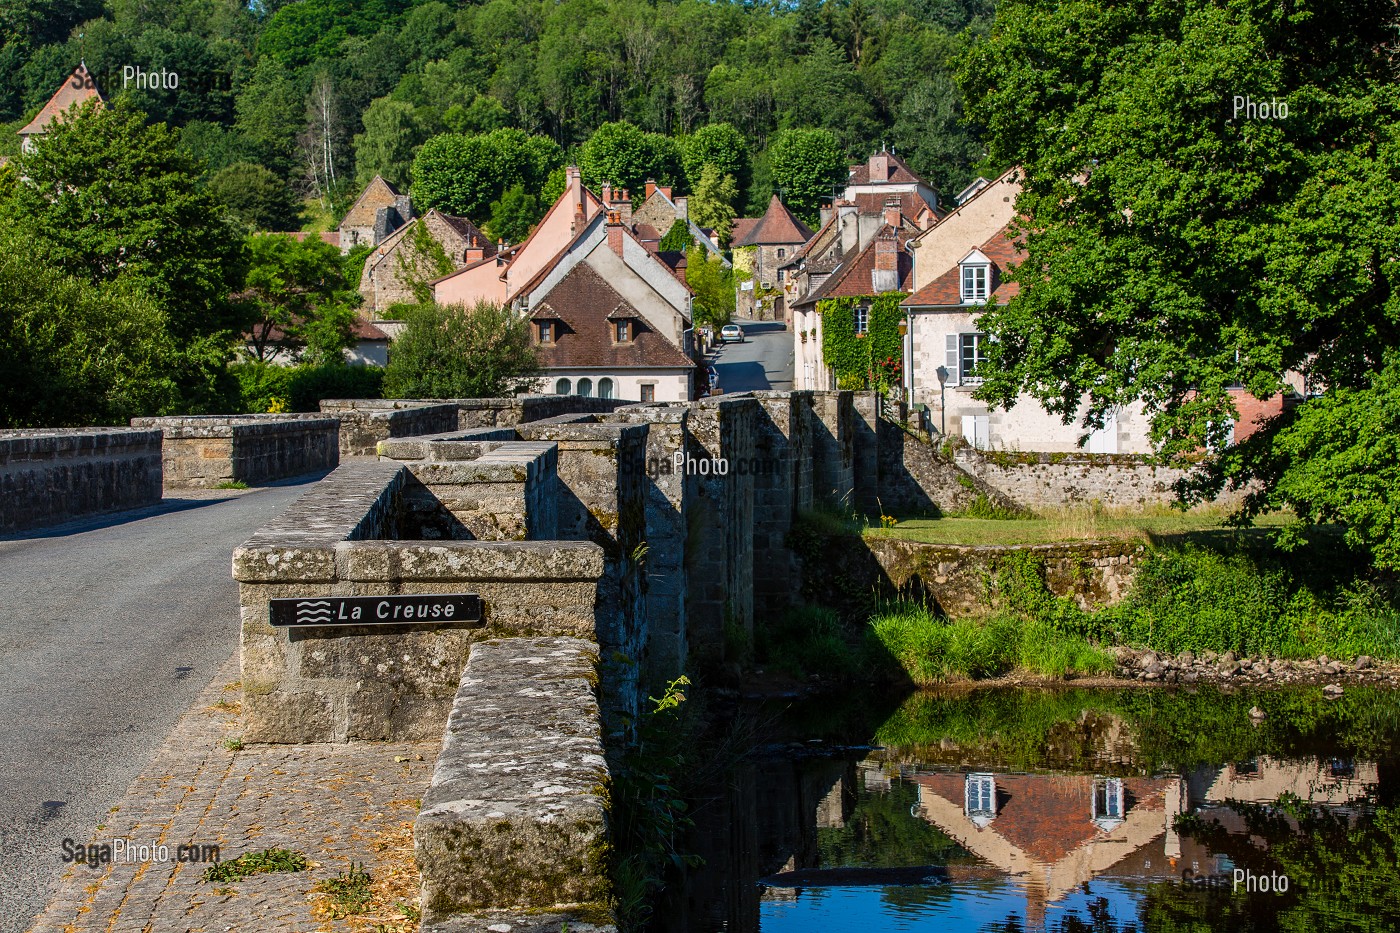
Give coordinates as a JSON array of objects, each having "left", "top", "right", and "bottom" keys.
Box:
[{"left": 960, "top": 0, "right": 1400, "bottom": 555}]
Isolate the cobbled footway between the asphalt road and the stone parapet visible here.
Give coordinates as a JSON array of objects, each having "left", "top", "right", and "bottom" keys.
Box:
[{"left": 31, "top": 657, "right": 438, "bottom": 933}]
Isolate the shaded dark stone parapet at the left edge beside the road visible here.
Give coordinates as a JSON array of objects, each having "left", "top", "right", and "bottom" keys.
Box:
[{"left": 0, "top": 427, "right": 161, "bottom": 534}]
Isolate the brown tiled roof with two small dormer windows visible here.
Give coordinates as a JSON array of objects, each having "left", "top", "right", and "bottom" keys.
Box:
[{"left": 531, "top": 262, "right": 694, "bottom": 370}]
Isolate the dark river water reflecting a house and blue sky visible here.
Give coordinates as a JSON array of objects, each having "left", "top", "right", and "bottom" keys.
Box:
[{"left": 654, "top": 688, "right": 1400, "bottom": 933}]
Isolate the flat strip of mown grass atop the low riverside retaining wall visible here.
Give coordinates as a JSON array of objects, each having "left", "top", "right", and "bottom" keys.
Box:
[{"left": 865, "top": 509, "right": 1289, "bottom": 545}]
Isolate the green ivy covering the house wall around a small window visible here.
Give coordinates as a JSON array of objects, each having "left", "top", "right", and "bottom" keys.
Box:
[{"left": 818, "top": 291, "right": 906, "bottom": 392}]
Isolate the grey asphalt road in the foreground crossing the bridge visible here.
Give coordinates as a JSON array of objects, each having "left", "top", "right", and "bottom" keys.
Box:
[{"left": 0, "top": 482, "right": 316, "bottom": 933}]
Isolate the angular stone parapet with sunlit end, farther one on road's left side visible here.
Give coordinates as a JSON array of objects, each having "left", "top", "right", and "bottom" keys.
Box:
[{"left": 132, "top": 415, "right": 340, "bottom": 489}]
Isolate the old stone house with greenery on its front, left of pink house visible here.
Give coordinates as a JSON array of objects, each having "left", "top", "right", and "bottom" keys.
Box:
[{"left": 358, "top": 207, "right": 496, "bottom": 317}]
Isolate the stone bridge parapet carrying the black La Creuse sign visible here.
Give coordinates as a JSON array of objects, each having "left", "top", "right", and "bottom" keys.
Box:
[{"left": 234, "top": 461, "right": 603, "bottom": 742}]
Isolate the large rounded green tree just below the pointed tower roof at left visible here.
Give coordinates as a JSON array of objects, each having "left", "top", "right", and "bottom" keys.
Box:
[{"left": 10, "top": 101, "right": 244, "bottom": 340}]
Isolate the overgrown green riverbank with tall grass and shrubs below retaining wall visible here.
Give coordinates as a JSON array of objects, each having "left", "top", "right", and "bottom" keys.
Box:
[{"left": 756, "top": 514, "right": 1400, "bottom": 685}]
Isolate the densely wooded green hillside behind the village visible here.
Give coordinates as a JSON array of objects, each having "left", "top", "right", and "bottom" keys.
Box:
[{"left": 0, "top": 0, "right": 993, "bottom": 224}]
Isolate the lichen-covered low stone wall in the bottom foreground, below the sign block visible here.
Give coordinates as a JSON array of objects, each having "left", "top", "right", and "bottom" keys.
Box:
[{"left": 413, "top": 637, "right": 610, "bottom": 930}]
